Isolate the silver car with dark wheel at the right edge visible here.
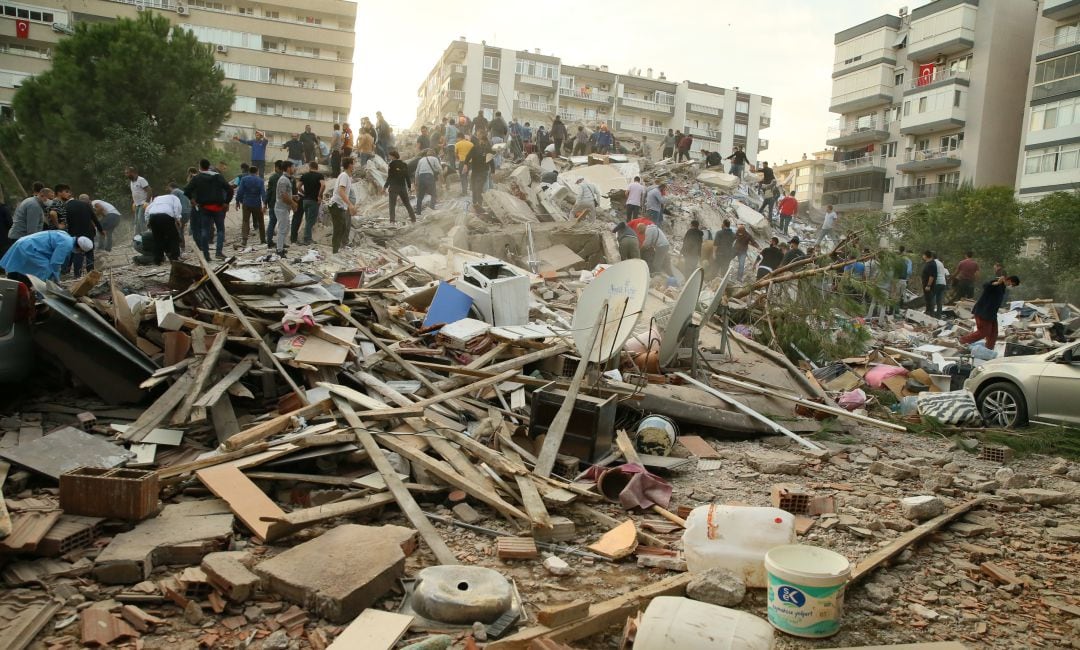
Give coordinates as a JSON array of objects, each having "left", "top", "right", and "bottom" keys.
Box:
[{"left": 963, "top": 341, "right": 1080, "bottom": 428}]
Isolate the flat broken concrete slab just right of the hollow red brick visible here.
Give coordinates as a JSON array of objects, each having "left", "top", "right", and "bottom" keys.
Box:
[{"left": 94, "top": 499, "right": 233, "bottom": 584}]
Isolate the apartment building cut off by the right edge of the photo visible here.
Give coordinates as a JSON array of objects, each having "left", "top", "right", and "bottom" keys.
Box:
[{"left": 1016, "top": 0, "right": 1080, "bottom": 201}]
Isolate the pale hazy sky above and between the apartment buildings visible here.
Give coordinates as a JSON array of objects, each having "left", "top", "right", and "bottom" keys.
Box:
[{"left": 350, "top": 0, "right": 898, "bottom": 164}]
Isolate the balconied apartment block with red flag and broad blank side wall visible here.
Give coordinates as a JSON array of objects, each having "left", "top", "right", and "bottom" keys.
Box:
[{"left": 823, "top": 0, "right": 1036, "bottom": 212}]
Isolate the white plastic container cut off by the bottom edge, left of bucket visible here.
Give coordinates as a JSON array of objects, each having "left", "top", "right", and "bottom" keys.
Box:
[{"left": 634, "top": 596, "right": 774, "bottom": 650}]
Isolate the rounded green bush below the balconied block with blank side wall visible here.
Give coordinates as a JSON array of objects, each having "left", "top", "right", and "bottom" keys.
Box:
[{"left": 895, "top": 186, "right": 1026, "bottom": 269}]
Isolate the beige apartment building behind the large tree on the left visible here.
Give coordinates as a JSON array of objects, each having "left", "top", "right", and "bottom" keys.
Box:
[{"left": 0, "top": 0, "right": 356, "bottom": 143}]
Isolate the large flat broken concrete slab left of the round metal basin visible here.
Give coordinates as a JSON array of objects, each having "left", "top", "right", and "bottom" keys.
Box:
[{"left": 255, "top": 524, "right": 417, "bottom": 624}]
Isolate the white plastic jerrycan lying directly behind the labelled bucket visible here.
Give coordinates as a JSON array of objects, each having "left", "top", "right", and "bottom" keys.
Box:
[{"left": 683, "top": 504, "right": 795, "bottom": 587}]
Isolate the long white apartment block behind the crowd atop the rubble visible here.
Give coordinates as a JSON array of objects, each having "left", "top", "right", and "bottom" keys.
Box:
[{"left": 414, "top": 39, "right": 772, "bottom": 161}]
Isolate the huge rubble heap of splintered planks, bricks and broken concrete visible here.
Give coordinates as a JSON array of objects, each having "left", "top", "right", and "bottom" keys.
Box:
[{"left": 0, "top": 155, "right": 1080, "bottom": 650}]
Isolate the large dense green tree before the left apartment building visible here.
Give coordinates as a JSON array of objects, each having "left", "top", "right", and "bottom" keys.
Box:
[{"left": 0, "top": 12, "right": 235, "bottom": 205}]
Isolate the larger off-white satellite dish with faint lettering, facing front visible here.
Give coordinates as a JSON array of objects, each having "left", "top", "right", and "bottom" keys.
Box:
[{"left": 570, "top": 259, "right": 643, "bottom": 363}]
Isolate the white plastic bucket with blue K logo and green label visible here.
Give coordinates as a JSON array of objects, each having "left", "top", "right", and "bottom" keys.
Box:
[{"left": 765, "top": 544, "right": 851, "bottom": 638}]
